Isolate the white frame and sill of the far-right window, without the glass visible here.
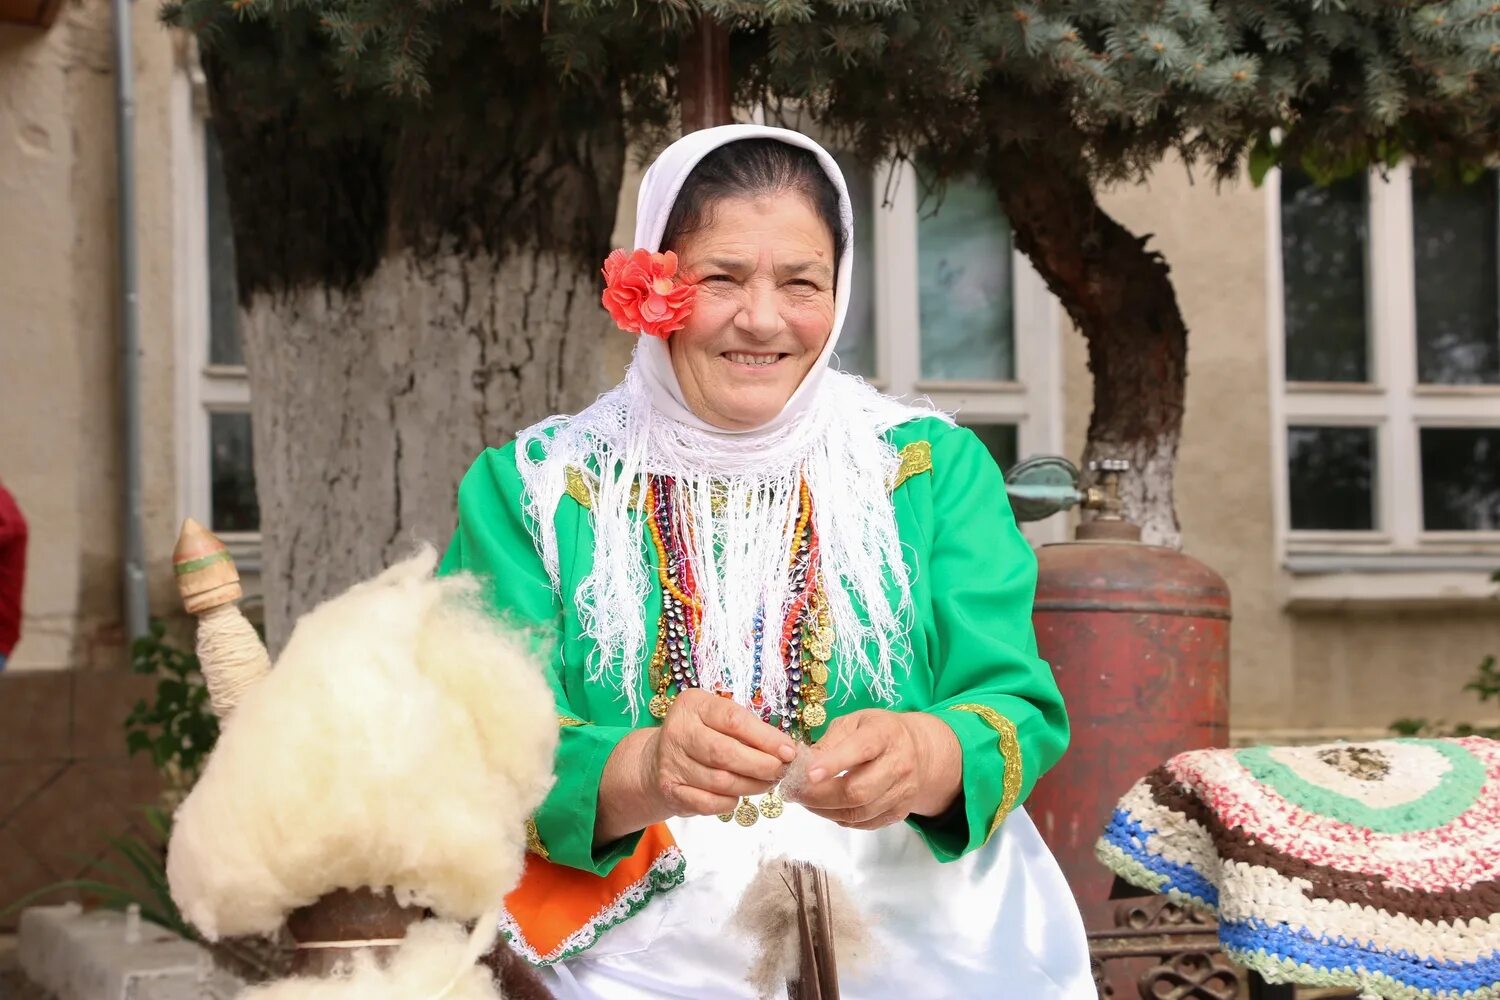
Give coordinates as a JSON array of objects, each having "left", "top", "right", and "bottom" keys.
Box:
[{"left": 1265, "top": 163, "right": 1500, "bottom": 601}]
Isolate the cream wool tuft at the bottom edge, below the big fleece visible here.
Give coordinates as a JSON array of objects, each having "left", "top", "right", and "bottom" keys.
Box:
[{"left": 237, "top": 921, "right": 504, "bottom": 1000}]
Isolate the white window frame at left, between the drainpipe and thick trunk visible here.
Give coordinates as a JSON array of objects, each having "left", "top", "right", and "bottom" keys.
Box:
[{"left": 170, "top": 40, "right": 261, "bottom": 574}]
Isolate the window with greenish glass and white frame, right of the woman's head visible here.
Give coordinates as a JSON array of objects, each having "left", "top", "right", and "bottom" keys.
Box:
[{"left": 839, "top": 157, "right": 1064, "bottom": 521}]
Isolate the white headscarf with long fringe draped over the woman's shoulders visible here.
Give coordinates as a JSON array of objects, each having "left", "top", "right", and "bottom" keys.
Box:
[{"left": 516, "top": 124, "right": 933, "bottom": 714}]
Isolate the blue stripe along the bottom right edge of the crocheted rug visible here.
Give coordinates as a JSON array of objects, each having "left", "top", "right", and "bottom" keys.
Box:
[{"left": 1220, "top": 919, "right": 1500, "bottom": 996}]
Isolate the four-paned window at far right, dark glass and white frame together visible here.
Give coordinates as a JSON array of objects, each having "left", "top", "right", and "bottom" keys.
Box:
[{"left": 1268, "top": 166, "right": 1500, "bottom": 571}]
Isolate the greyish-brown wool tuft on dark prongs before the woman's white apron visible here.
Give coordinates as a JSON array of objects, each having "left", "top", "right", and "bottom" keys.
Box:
[{"left": 729, "top": 858, "right": 872, "bottom": 999}]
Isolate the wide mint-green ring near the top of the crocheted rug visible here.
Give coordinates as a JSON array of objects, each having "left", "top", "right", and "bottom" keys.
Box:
[{"left": 1235, "top": 739, "right": 1485, "bottom": 834}]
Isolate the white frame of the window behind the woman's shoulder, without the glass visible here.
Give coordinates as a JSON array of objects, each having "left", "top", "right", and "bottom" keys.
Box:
[{"left": 855, "top": 162, "right": 1068, "bottom": 544}]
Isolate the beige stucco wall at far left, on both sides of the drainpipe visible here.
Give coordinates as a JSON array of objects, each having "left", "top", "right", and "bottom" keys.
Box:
[{"left": 0, "top": 0, "right": 186, "bottom": 670}]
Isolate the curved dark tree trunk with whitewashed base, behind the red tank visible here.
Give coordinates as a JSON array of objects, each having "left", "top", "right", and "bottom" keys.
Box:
[{"left": 990, "top": 144, "right": 1188, "bottom": 549}]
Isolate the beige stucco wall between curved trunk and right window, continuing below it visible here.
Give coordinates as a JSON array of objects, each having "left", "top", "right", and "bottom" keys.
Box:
[{"left": 1064, "top": 162, "right": 1500, "bottom": 741}]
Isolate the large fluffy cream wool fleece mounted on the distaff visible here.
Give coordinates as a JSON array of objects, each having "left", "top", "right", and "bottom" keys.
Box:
[{"left": 167, "top": 547, "right": 558, "bottom": 940}]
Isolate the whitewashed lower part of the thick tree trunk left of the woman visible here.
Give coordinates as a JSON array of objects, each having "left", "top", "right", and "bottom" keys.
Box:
[{"left": 243, "top": 247, "right": 612, "bottom": 649}]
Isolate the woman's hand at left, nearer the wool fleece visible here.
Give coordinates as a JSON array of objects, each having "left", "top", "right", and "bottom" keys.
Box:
[{"left": 594, "top": 688, "right": 797, "bottom": 844}]
